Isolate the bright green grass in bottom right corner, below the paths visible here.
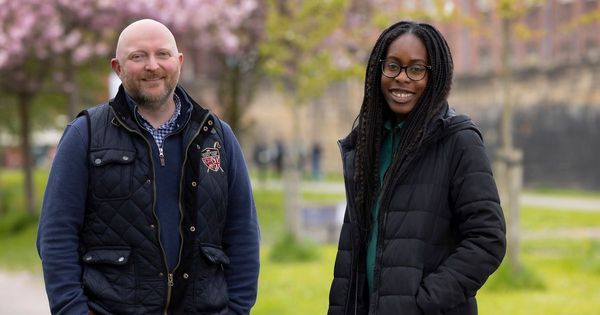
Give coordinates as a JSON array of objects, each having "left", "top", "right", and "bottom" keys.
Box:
[{"left": 478, "top": 240, "right": 600, "bottom": 315}]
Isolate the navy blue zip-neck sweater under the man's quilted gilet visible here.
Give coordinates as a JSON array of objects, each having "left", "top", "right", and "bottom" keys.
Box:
[{"left": 37, "top": 90, "right": 259, "bottom": 314}]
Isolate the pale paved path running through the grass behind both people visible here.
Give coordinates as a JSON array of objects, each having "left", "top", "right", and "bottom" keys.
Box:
[{"left": 0, "top": 181, "right": 600, "bottom": 315}]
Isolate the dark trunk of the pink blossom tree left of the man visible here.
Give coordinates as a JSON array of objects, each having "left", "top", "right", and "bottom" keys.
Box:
[{"left": 18, "top": 93, "right": 37, "bottom": 215}]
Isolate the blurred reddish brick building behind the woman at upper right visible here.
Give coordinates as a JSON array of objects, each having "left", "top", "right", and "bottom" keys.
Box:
[{"left": 401, "top": 0, "right": 600, "bottom": 75}]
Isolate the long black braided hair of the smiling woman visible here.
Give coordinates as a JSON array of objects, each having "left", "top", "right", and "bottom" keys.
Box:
[{"left": 354, "top": 21, "right": 453, "bottom": 244}]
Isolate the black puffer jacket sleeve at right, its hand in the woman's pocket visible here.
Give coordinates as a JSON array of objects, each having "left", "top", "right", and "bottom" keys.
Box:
[{"left": 417, "top": 129, "right": 506, "bottom": 314}]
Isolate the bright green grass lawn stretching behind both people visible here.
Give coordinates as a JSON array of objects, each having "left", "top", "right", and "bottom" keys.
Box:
[{"left": 0, "top": 172, "right": 600, "bottom": 315}]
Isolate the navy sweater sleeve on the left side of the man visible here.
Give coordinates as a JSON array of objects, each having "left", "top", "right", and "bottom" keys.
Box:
[{"left": 37, "top": 117, "right": 88, "bottom": 315}]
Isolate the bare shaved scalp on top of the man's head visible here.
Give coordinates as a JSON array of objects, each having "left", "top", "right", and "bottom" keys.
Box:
[{"left": 115, "top": 19, "right": 179, "bottom": 61}]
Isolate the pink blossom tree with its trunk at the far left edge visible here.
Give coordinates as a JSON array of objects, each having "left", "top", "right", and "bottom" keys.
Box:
[{"left": 0, "top": 0, "right": 122, "bottom": 214}]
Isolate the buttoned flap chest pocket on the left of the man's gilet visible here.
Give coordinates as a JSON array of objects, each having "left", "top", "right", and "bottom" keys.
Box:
[{"left": 90, "top": 149, "right": 135, "bottom": 199}]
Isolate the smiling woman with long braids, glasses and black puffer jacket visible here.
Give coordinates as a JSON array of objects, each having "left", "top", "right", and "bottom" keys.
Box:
[{"left": 329, "top": 21, "right": 506, "bottom": 315}]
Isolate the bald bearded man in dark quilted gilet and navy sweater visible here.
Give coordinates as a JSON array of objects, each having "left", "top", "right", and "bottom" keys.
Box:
[{"left": 37, "top": 19, "right": 259, "bottom": 315}]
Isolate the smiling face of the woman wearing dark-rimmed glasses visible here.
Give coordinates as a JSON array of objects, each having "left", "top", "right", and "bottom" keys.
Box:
[{"left": 381, "top": 33, "right": 429, "bottom": 122}]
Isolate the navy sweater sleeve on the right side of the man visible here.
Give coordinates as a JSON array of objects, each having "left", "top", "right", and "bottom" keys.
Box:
[{"left": 223, "top": 123, "right": 260, "bottom": 315}]
